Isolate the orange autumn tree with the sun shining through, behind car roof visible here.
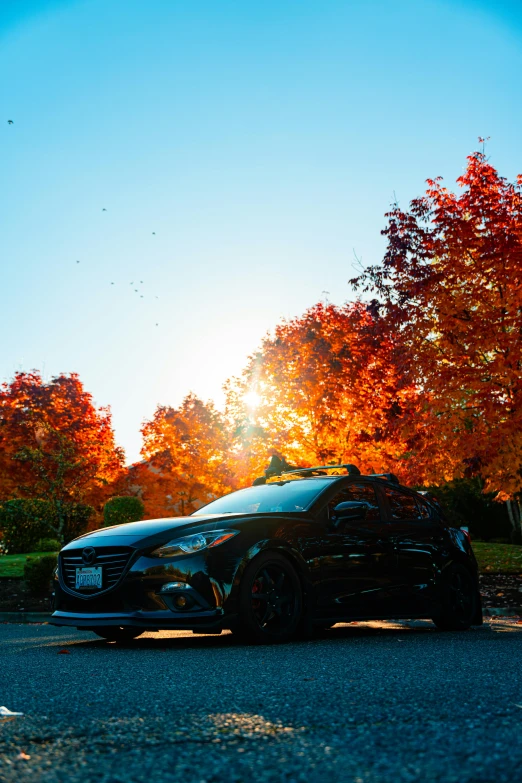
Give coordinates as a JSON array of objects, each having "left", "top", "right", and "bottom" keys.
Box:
[{"left": 223, "top": 303, "right": 419, "bottom": 477}]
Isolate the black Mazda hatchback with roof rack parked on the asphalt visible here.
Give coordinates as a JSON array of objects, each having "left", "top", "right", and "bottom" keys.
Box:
[{"left": 51, "top": 460, "right": 482, "bottom": 642}]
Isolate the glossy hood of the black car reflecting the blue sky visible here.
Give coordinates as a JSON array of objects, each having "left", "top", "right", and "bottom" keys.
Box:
[{"left": 64, "top": 514, "right": 244, "bottom": 549}]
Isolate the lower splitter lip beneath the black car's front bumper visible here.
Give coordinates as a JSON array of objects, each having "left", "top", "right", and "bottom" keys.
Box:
[{"left": 49, "top": 610, "right": 233, "bottom": 631}]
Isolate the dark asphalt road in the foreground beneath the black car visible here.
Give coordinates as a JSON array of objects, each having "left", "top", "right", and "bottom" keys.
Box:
[{"left": 0, "top": 619, "right": 522, "bottom": 783}]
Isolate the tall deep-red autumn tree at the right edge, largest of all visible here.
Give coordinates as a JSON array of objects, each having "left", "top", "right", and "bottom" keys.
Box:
[{"left": 351, "top": 152, "right": 522, "bottom": 496}]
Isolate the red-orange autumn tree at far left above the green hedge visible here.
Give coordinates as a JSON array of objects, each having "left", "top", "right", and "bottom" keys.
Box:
[{"left": 0, "top": 372, "right": 123, "bottom": 532}]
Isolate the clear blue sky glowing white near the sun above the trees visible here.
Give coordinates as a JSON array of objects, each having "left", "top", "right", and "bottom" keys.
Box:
[{"left": 0, "top": 0, "right": 522, "bottom": 460}]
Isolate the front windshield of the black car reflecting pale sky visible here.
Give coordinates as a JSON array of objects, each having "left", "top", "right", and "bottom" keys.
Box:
[{"left": 192, "top": 479, "right": 331, "bottom": 516}]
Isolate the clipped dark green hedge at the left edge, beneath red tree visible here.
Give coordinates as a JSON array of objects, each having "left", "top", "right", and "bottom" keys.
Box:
[{"left": 0, "top": 498, "right": 94, "bottom": 555}]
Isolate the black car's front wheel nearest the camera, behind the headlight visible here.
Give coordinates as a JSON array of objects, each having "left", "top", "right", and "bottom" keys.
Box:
[{"left": 235, "top": 552, "right": 303, "bottom": 644}]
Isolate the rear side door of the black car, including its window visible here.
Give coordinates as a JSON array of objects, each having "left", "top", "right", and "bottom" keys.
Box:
[{"left": 381, "top": 486, "right": 443, "bottom": 613}]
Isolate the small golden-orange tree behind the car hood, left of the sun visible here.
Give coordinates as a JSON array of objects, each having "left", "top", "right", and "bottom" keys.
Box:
[{"left": 139, "top": 394, "right": 235, "bottom": 517}]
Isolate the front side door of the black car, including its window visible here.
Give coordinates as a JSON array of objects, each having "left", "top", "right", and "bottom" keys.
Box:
[{"left": 314, "top": 480, "right": 390, "bottom": 618}]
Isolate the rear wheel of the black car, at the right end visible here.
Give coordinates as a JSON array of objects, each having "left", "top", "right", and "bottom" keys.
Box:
[{"left": 433, "top": 564, "right": 477, "bottom": 631}]
